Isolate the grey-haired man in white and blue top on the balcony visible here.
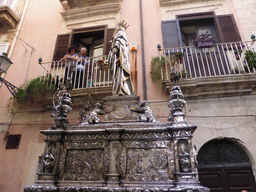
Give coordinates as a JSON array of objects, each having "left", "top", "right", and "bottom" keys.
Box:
[{"left": 74, "top": 47, "right": 88, "bottom": 88}]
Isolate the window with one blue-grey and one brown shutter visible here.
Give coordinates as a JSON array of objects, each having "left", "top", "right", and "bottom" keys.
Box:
[{"left": 162, "top": 12, "right": 241, "bottom": 48}]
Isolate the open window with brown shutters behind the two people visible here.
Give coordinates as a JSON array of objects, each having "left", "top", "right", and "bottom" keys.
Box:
[{"left": 53, "top": 25, "right": 114, "bottom": 61}]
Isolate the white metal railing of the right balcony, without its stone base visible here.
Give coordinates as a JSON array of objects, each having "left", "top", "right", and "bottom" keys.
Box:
[{"left": 159, "top": 41, "right": 256, "bottom": 81}]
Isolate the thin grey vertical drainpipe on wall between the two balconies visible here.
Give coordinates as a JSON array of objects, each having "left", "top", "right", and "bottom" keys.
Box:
[{"left": 139, "top": 0, "right": 148, "bottom": 100}]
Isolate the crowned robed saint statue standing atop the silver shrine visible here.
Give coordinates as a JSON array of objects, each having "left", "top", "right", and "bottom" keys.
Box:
[{"left": 108, "top": 21, "right": 134, "bottom": 96}]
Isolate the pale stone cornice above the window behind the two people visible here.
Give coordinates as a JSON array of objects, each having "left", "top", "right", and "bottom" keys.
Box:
[{"left": 61, "top": 3, "right": 121, "bottom": 21}]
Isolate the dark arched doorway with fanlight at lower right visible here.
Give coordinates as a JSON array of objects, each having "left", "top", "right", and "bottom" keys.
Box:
[{"left": 197, "top": 139, "right": 256, "bottom": 192}]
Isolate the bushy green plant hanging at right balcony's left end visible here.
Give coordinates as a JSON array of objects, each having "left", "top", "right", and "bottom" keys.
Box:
[{"left": 150, "top": 57, "right": 165, "bottom": 82}]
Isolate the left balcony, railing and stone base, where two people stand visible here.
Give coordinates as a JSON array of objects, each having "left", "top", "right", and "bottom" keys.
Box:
[{"left": 38, "top": 56, "right": 112, "bottom": 108}]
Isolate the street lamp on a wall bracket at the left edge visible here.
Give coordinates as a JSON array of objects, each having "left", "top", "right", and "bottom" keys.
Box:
[{"left": 0, "top": 53, "right": 18, "bottom": 97}]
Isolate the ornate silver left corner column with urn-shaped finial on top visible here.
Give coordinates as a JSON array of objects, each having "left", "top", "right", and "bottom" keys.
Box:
[{"left": 33, "top": 86, "right": 72, "bottom": 191}]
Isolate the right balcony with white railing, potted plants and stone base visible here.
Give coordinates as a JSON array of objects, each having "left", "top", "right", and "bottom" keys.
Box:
[{"left": 159, "top": 42, "right": 256, "bottom": 99}]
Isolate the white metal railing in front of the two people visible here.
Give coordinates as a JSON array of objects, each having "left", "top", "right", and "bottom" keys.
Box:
[{"left": 38, "top": 56, "right": 112, "bottom": 89}]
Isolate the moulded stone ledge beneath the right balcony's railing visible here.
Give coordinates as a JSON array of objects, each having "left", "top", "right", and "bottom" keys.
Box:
[{"left": 162, "top": 73, "right": 256, "bottom": 99}]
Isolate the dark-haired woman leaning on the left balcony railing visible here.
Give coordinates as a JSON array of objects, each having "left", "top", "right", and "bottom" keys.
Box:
[{"left": 60, "top": 46, "right": 79, "bottom": 84}]
